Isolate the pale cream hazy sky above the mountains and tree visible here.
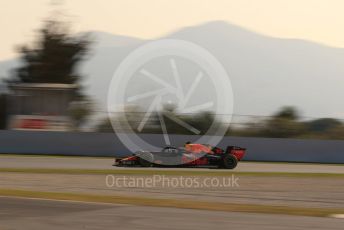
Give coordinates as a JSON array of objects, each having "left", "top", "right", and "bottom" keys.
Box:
[{"left": 0, "top": 0, "right": 344, "bottom": 60}]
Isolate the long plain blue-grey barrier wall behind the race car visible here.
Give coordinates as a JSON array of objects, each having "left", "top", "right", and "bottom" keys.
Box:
[{"left": 0, "top": 130, "right": 344, "bottom": 163}]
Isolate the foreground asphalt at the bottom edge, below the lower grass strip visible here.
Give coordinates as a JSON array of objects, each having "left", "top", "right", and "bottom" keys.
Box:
[{"left": 0, "top": 197, "right": 344, "bottom": 230}]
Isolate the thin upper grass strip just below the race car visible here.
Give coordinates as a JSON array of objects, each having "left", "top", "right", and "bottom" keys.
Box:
[{"left": 0, "top": 168, "right": 344, "bottom": 178}]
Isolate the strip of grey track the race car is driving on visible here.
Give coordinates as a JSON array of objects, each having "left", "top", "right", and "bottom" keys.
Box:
[{"left": 0, "top": 155, "right": 344, "bottom": 173}]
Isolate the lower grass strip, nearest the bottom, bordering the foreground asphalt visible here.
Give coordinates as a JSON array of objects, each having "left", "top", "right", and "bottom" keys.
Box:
[{"left": 0, "top": 189, "right": 344, "bottom": 217}]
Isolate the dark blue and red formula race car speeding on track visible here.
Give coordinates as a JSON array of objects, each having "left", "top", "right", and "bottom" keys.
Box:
[{"left": 113, "top": 143, "right": 246, "bottom": 169}]
